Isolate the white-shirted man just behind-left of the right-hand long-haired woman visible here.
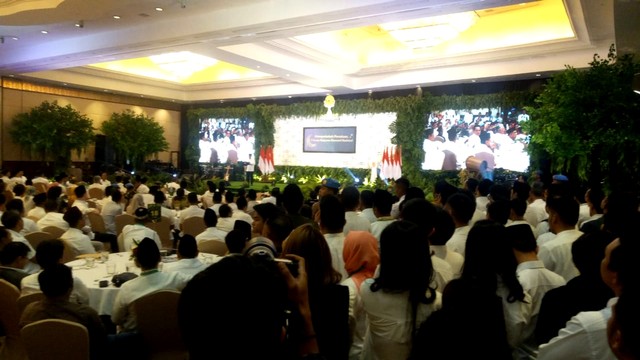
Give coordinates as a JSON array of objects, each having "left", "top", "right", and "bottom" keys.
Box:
[{"left": 444, "top": 193, "right": 475, "bottom": 256}]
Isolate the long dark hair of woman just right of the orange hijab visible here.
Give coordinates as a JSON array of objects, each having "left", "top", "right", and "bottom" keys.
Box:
[{"left": 371, "top": 220, "right": 433, "bottom": 302}]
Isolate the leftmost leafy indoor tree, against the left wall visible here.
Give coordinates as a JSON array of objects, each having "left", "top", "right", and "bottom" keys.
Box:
[{"left": 9, "top": 101, "right": 95, "bottom": 171}]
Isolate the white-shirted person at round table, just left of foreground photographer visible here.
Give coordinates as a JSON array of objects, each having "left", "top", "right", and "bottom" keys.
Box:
[{"left": 111, "top": 237, "right": 189, "bottom": 332}]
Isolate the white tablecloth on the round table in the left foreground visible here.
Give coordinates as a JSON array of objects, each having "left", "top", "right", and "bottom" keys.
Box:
[{"left": 66, "top": 252, "right": 219, "bottom": 315}]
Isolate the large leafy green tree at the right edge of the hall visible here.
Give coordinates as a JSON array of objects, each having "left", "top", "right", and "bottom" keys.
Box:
[{"left": 526, "top": 45, "right": 640, "bottom": 188}]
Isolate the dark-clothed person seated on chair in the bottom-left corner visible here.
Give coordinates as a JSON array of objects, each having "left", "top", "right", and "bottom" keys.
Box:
[{"left": 20, "top": 264, "right": 107, "bottom": 359}]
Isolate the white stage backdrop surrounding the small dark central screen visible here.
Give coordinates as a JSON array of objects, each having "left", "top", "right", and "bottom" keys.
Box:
[{"left": 273, "top": 113, "right": 396, "bottom": 169}]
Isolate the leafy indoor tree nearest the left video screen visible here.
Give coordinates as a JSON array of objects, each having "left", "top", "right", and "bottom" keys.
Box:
[{"left": 100, "top": 109, "right": 169, "bottom": 168}]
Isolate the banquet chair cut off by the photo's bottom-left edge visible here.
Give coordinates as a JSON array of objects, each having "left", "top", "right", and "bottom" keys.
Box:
[{"left": 0, "top": 279, "right": 27, "bottom": 360}]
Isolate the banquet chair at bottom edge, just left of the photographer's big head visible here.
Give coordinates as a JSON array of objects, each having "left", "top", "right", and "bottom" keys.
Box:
[{"left": 133, "top": 290, "right": 188, "bottom": 360}]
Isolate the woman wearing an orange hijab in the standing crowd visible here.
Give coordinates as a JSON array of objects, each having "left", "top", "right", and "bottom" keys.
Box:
[{"left": 342, "top": 231, "right": 380, "bottom": 359}]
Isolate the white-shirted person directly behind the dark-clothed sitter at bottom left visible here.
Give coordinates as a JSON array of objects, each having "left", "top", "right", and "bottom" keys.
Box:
[{"left": 21, "top": 239, "right": 89, "bottom": 305}]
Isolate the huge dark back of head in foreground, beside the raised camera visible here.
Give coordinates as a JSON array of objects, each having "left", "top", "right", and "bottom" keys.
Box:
[{"left": 178, "top": 256, "right": 287, "bottom": 359}]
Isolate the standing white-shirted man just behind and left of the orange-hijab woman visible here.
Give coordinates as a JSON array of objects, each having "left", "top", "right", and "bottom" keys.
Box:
[{"left": 319, "top": 195, "right": 349, "bottom": 279}]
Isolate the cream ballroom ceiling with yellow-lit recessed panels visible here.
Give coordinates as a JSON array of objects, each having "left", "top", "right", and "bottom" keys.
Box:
[{"left": 0, "top": 0, "right": 638, "bottom": 103}]
